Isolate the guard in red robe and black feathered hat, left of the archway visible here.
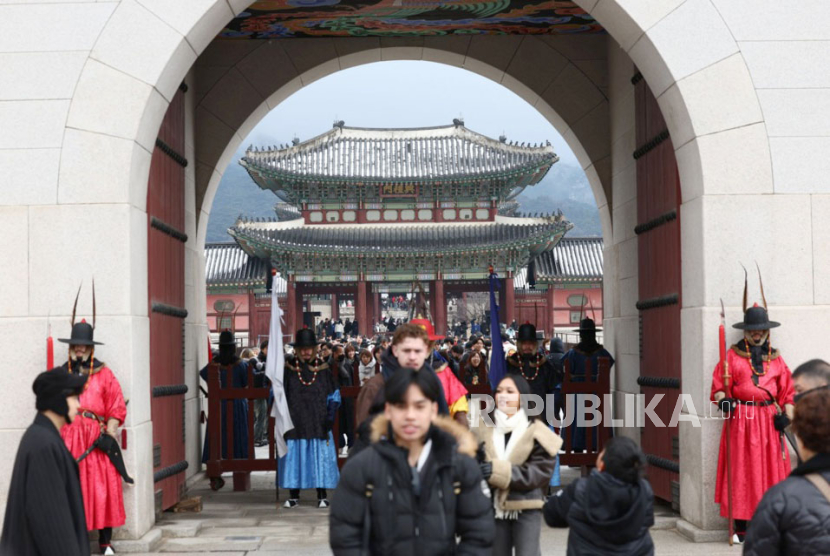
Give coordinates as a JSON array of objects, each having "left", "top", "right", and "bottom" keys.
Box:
[{"left": 59, "top": 322, "right": 127, "bottom": 554}]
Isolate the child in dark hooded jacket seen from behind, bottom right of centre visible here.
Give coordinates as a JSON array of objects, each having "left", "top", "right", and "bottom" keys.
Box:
[{"left": 543, "top": 436, "right": 654, "bottom": 556}]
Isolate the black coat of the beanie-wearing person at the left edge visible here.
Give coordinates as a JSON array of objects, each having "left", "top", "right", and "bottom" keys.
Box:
[{"left": 0, "top": 414, "right": 89, "bottom": 556}]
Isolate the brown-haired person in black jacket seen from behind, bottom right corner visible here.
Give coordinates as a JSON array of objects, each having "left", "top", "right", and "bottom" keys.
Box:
[{"left": 744, "top": 388, "right": 830, "bottom": 556}]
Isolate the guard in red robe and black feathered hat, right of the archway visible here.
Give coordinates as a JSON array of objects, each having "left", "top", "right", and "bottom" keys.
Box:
[{"left": 711, "top": 296, "right": 795, "bottom": 543}]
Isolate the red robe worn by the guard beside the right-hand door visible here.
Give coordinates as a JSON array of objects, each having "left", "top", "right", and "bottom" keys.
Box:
[{"left": 711, "top": 346, "right": 794, "bottom": 520}]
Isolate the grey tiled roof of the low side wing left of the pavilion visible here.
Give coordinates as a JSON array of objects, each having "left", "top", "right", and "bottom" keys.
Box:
[{"left": 205, "top": 243, "right": 286, "bottom": 295}]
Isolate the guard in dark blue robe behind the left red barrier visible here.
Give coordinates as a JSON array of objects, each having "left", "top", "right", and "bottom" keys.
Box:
[{"left": 199, "top": 330, "right": 248, "bottom": 490}]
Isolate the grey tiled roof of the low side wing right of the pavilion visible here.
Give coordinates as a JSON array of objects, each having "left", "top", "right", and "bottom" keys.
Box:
[{"left": 514, "top": 237, "right": 603, "bottom": 288}]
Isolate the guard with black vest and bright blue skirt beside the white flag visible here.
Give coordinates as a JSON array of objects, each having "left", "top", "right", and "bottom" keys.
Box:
[{"left": 277, "top": 328, "right": 340, "bottom": 508}]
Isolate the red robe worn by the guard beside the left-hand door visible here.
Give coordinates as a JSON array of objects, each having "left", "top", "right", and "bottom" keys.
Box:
[{"left": 61, "top": 366, "right": 127, "bottom": 531}]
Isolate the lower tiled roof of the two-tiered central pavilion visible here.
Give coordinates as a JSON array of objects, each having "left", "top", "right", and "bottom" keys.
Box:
[{"left": 228, "top": 217, "right": 572, "bottom": 254}]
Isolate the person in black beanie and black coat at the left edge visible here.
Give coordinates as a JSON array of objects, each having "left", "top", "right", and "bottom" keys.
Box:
[{"left": 0, "top": 369, "right": 89, "bottom": 556}]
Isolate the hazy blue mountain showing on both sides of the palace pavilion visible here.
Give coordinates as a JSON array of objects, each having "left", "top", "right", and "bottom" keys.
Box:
[{"left": 207, "top": 162, "right": 602, "bottom": 243}]
